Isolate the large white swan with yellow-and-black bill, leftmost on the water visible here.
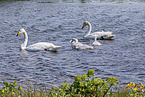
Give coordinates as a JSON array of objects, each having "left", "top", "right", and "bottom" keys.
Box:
[{"left": 17, "top": 28, "right": 61, "bottom": 51}]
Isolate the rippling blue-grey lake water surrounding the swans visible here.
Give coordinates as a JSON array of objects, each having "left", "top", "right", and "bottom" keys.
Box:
[{"left": 0, "top": 0, "right": 145, "bottom": 88}]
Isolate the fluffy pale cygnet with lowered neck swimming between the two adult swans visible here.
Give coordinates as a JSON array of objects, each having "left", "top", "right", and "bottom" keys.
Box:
[{"left": 70, "top": 38, "right": 93, "bottom": 50}]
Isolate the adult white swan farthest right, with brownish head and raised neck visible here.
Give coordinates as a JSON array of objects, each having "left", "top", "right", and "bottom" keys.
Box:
[{"left": 82, "top": 21, "right": 115, "bottom": 39}]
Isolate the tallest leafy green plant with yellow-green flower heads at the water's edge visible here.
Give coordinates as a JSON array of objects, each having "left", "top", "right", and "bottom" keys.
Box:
[{"left": 51, "top": 69, "right": 119, "bottom": 97}]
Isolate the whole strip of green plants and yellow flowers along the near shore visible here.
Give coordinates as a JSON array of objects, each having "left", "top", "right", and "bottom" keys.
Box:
[{"left": 0, "top": 69, "right": 145, "bottom": 97}]
